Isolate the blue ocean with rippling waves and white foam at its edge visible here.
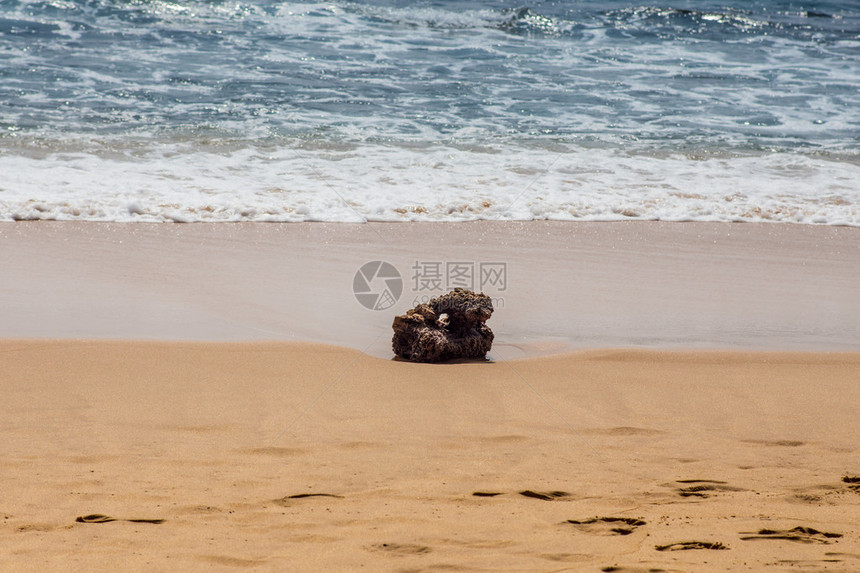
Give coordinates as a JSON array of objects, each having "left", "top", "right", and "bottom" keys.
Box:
[{"left": 0, "top": 0, "right": 860, "bottom": 226}]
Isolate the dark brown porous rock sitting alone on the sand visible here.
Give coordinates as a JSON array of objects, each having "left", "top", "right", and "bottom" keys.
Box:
[{"left": 391, "top": 288, "right": 493, "bottom": 362}]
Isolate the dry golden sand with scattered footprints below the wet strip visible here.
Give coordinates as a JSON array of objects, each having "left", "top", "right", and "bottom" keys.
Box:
[{"left": 0, "top": 340, "right": 860, "bottom": 571}]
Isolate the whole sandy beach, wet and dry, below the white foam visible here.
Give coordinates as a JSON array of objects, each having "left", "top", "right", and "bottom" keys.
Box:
[{"left": 0, "top": 223, "right": 860, "bottom": 571}]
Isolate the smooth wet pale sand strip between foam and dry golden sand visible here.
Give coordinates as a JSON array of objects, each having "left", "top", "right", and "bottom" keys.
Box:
[{"left": 0, "top": 221, "right": 860, "bottom": 354}]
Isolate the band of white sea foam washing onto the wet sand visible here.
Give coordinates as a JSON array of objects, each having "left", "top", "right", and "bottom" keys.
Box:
[{"left": 0, "top": 140, "right": 860, "bottom": 226}]
